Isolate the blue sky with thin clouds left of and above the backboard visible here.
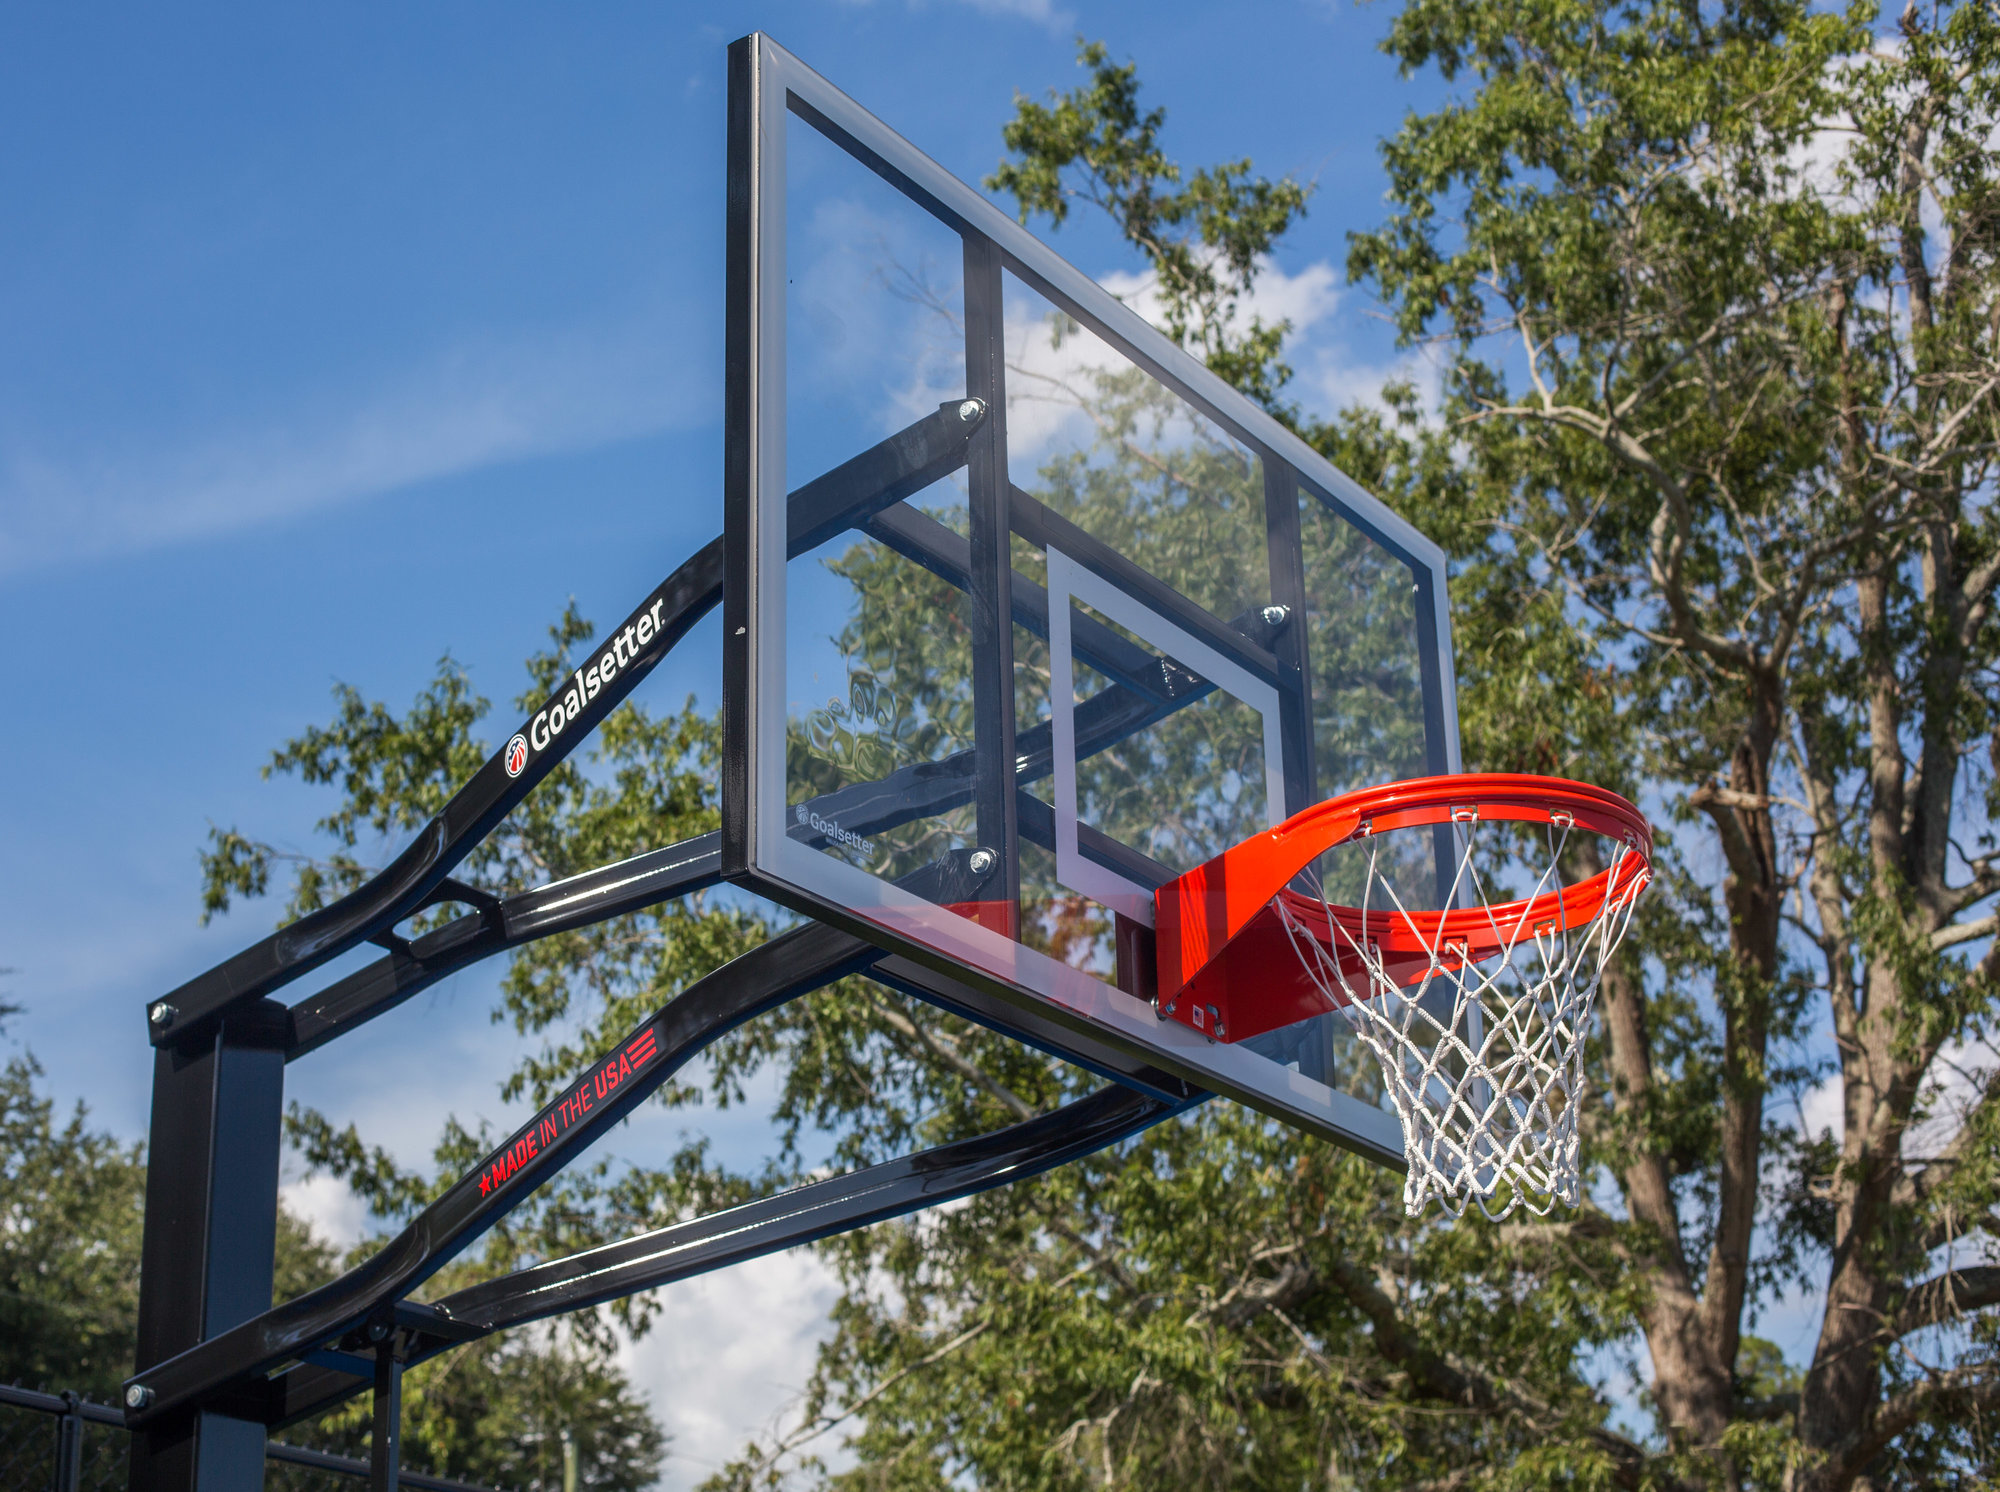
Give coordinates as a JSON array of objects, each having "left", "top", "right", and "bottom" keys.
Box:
[{"left": 0, "top": 0, "right": 1434, "bottom": 1468}]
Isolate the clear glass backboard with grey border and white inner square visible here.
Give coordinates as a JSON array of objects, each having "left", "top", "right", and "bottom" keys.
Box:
[{"left": 722, "top": 36, "right": 1458, "bottom": 1162}]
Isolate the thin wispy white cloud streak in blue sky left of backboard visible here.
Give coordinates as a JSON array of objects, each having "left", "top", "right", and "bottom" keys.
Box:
[{"left": 0, "top": 314, "right": 714, "bottom": 574}]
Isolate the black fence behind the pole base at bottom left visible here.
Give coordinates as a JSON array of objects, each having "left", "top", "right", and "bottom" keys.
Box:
[{"left": 0, "top": 1384, "right": 494, "bottom": 1492}]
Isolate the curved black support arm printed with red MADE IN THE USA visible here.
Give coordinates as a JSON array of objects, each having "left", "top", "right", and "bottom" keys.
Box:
[{"left": 126, "top": 922, "right": 882, "bottom": 1428}]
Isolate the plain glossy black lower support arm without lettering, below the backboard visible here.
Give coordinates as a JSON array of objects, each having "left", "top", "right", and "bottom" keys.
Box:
[{"left": 268, "top": 1088, "right": 1202, "bottom": 1426}]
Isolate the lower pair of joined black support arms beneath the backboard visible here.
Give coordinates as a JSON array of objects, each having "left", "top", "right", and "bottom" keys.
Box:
[{"left": 126, "top": 908, "right": 1204, "bottom": 1428}]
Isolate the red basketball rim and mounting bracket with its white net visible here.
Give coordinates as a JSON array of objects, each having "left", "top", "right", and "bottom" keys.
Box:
[{"left": 1156, "top": 774, "right": 1652, "bottom": 1220}]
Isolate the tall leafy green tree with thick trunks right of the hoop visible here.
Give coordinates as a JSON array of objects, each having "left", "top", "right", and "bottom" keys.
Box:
[{"left": 1352, "top": 0, "right": 2000, "bottom": 1488}]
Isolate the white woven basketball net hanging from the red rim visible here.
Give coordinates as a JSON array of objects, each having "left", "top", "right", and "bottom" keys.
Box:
[{"left": 1272, "top": 818, "right": 1646, "bottom": 1222}]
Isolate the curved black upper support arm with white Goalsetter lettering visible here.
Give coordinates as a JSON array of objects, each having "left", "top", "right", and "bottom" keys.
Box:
[{"left": 148, "top": 400, "right": 986, "bottom": 1046}]
